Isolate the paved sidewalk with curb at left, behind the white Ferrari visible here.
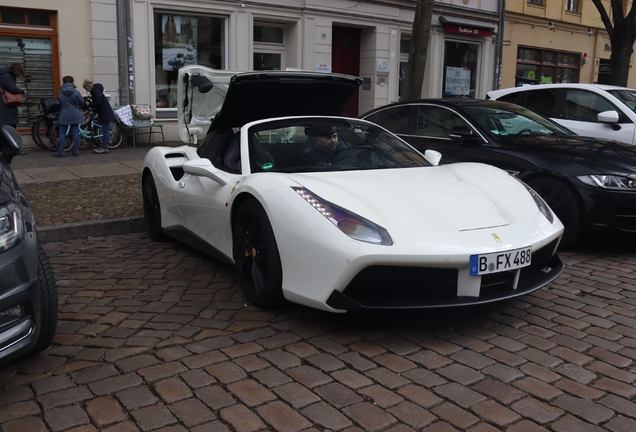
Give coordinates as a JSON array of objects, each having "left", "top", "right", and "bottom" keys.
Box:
[{"left": 11, "top": 141, "right": 183, "bottom": 243}]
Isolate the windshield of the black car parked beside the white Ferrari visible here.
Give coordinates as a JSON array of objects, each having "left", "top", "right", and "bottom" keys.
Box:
[{"left": 465, "top": 104, "right": 573, "bottom": 140}]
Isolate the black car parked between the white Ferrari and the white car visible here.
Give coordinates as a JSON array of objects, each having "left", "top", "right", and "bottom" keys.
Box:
[{"left": 361, "top": 99, "right": 636, "bottom": 247}]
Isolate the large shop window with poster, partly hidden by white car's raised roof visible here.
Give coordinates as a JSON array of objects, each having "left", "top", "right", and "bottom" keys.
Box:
[{"left": 154, "top": 12, "right": 227, "bottom": 113}]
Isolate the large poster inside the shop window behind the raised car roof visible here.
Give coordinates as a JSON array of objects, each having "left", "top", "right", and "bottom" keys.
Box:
[{"left": 162, "top": 15, "right": 197, "bottom": 71}]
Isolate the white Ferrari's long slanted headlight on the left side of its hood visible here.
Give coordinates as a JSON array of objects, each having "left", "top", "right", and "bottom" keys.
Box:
[{"left": 292, "top": 187, "right": 393, "bottom": 246}]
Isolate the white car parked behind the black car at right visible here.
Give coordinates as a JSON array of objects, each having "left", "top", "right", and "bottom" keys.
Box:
[{"left": 487, "top": 83, "right": 636, "bottom": 144}]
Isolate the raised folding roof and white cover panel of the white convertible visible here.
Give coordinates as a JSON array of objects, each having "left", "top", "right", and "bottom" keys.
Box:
[{"left": 177, "top": 66, "right": 362, "bottom": 142}]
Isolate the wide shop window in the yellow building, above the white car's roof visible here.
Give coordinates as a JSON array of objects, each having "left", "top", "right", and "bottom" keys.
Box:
[{"left": 515, "top": 47, "right": 581, "bottom": 85}]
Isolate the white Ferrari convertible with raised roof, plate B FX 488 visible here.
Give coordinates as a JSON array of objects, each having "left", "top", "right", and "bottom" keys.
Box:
[{"left": 142, "top": 66, "right": 563, "bottom": 312}]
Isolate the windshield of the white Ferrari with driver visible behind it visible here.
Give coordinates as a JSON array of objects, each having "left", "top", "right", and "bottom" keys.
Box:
[{"left": 248, "top": 117, "right": 430, "bottom": 173}]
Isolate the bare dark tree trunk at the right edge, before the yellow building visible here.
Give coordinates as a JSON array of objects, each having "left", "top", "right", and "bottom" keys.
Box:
[{"left": 592, "top": 0, "right": 636, "bottom": 86}]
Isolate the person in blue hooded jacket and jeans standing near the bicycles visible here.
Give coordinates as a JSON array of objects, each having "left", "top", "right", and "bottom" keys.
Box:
[{"left": 53, "top": 75, "right": 84, "bottom": 157}]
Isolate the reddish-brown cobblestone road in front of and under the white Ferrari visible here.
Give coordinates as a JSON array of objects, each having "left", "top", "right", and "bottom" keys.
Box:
[{"left": 0, "top": 234, "right": 636, "bottom": 432}]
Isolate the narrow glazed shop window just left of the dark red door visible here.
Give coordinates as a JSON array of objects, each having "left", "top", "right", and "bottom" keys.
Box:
[{"left": 252, "top": 23, "right": 285, "bottom": 70}]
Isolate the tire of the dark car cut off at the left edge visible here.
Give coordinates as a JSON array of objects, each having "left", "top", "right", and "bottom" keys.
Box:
[{"left": 29, "top": 245, "right": 58, "bottom": 355}]
